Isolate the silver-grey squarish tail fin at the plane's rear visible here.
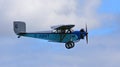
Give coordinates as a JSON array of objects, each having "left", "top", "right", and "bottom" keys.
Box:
[{"left": 14, "top": 21, "right": 26, "bottom": 35}]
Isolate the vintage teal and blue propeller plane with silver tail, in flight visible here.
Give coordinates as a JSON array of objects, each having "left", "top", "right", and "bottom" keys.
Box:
[{"left": 13, "top": 21, "right": 88, "bottom": 49}]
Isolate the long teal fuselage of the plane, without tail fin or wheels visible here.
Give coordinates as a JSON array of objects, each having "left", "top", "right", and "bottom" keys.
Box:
[{"left": 19, "top": 32, "right": 80, "bottom": 43}]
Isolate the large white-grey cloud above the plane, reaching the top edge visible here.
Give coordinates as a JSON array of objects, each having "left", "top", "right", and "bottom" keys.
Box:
[{"left": 0, "top": 0, "right": 100, "bottom": 35}]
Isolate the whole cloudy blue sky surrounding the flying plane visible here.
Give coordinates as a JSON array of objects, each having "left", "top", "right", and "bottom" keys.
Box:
[{"left": 0, "top": 0, "right": 120, "bottom": 67}]
